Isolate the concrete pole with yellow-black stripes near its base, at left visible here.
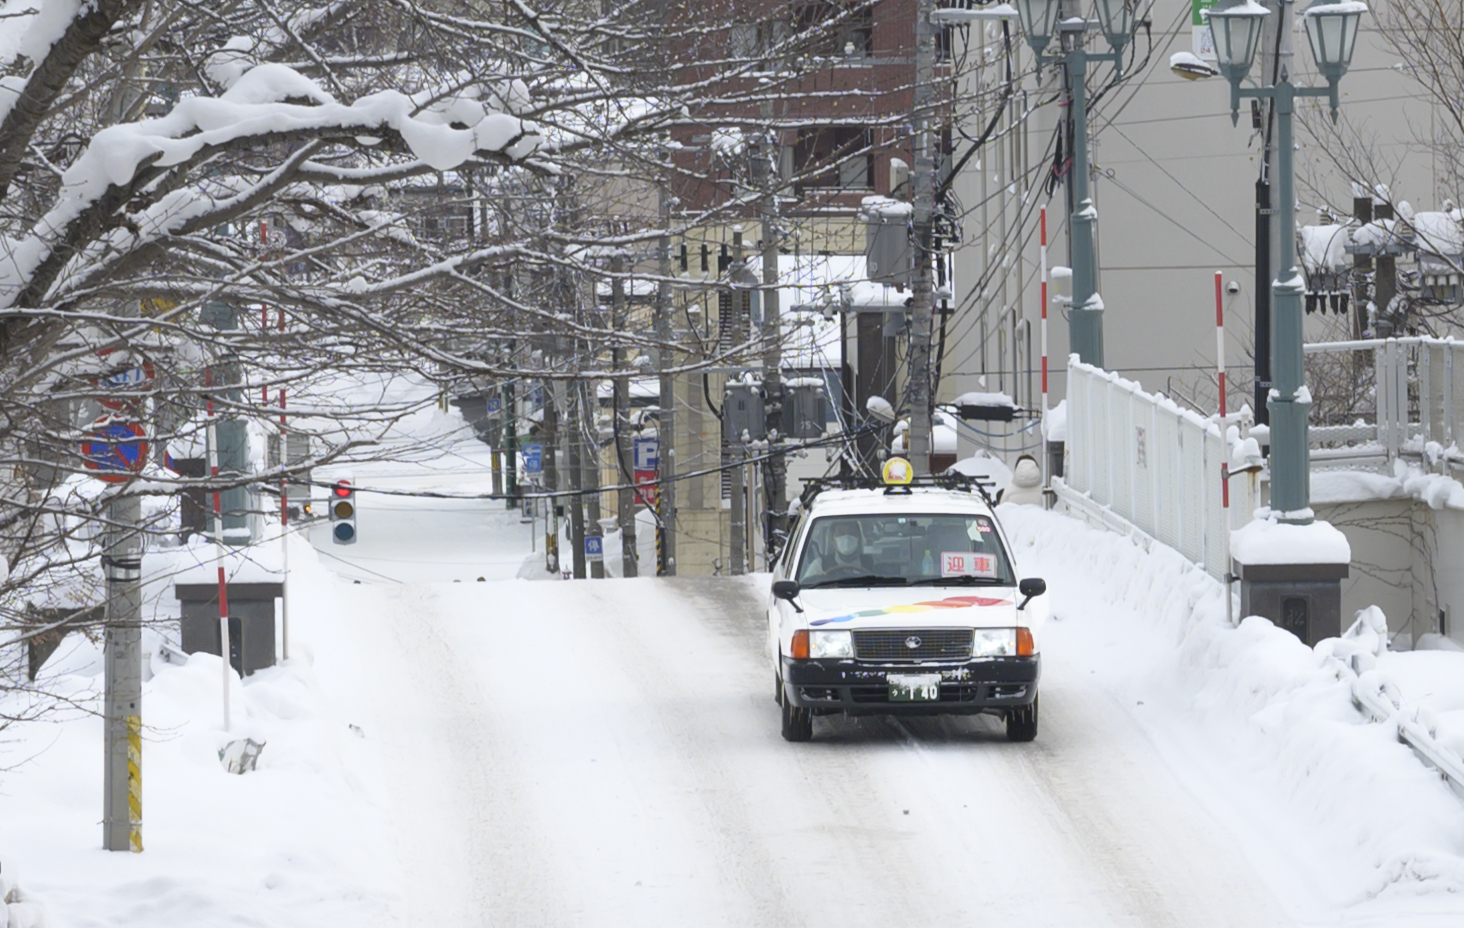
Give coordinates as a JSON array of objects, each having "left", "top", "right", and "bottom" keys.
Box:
[{"left": 102, "top": 496, "right": 143, "bottom": 852}]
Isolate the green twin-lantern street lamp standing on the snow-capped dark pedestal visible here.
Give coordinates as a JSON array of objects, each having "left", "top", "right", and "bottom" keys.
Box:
[{"left": 1209, "top": 0, "right": 1367, "bottom": 524}]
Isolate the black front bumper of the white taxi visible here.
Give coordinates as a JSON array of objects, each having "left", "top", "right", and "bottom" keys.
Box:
[{"left": 782, "top": 654, "right": 1042, "bottom": 716}]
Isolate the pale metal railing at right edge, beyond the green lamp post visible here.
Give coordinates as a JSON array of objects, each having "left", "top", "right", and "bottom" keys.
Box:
[{"left": 1304, "top": 335, "right": 1464, "bottom": 471}]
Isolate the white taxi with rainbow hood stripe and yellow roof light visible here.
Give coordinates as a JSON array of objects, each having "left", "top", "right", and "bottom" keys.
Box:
[{"left": 767, "top": 458, "right": 1047, "bottom": 741}]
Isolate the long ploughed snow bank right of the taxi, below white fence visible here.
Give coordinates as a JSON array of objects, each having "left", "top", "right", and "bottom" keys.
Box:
[{"left": 1000, "top": 506, "right": 1464, "bottom": 907}]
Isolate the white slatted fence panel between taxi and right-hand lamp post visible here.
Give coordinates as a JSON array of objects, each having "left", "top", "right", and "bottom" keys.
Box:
[{"left": 1058, "top": 359, "right": 1250, "bottom": 580}]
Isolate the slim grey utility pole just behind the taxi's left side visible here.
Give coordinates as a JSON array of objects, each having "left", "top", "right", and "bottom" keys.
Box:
[{"left": 752, "top": 130, "right": 788, "bottom": 568}]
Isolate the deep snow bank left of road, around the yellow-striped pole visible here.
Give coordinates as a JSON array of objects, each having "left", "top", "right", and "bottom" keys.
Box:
[{"left": 0, "top": 537, "right": 401, "bottom": 928}]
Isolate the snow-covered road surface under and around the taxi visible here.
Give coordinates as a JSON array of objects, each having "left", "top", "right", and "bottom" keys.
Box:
[{"left": 332, "top": 570, "right": 1293, "bottom": 927}]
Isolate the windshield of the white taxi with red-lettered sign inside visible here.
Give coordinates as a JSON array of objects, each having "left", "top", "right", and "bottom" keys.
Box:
[{"left": 795, "top": 514, "right": 1013, "bottom": 588}]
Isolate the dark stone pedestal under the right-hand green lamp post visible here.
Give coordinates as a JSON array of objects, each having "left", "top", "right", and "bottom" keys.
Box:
[{"left": 1233, "top": 562, "right": 1347, "bottom": 647}]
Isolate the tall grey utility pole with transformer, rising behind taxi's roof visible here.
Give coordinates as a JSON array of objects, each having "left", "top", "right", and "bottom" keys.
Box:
[{"left": 901, "top": 0, "right": 935, "bottom": 474}]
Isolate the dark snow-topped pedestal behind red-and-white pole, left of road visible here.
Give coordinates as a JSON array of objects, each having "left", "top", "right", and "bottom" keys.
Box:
[{"left": 173, "top": 583, "right": 284, "bottom": 676}]
